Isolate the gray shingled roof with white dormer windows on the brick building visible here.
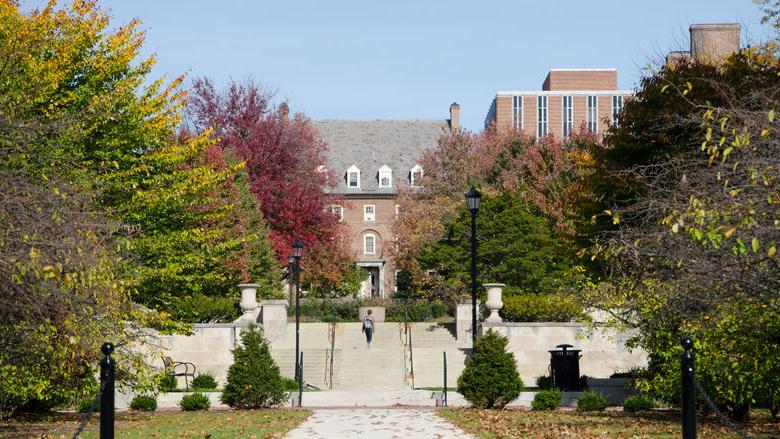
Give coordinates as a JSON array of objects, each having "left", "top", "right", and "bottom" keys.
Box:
[{"left": 314, "top": 120, "right": 449, "bottom": 194}]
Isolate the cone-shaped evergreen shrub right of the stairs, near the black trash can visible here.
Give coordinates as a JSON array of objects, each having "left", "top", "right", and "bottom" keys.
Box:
[{"left": 458, "top": 330, "right": 523, "bottom": 408}]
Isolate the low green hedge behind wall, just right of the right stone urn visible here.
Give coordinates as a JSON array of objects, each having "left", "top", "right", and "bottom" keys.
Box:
[{"left": 500, "top": 294, "right": 583, "bottom": 322}]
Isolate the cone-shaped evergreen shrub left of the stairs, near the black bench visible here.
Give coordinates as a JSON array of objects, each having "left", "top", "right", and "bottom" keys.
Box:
[{"left": 222, "top": 325, "right": 287, "bottom": 409}]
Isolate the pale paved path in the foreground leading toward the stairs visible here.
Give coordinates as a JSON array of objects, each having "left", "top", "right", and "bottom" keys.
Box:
[{"left": 287, "top": 408, "right": 473, "bottom": 439}]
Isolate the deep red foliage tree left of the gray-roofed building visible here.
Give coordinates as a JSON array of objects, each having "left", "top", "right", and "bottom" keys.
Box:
[{"left": 190, "top": 79, "right": 349, "bottom": 292}]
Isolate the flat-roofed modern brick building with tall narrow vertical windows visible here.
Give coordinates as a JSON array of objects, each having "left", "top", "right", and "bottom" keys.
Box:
[{"left": 485, "top": 69, "right": 632, "bottom": 138}]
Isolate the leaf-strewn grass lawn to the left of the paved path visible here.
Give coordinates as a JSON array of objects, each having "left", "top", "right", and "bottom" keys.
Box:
[{"left": 0, "top": 409, "right": 311, "bottom": 439}]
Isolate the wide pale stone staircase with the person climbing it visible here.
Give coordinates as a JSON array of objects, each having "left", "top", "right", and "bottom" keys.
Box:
[{"left": 271, "top": 322, "right": 470, "bottom": 390}]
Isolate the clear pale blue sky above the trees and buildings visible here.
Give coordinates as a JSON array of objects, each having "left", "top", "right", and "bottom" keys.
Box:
[{"left": 26, "top": 0, "right": 772, "bottom": 130}]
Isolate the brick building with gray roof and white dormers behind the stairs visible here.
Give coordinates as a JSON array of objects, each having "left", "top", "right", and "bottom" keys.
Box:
[{"left": 314, "top": 104, "right": 460, "bottom": 297}]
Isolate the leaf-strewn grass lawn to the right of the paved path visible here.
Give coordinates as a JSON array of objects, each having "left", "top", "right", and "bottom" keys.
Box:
[{"left": 439, "top": 409, "right": 780, "bottom": 439}]
